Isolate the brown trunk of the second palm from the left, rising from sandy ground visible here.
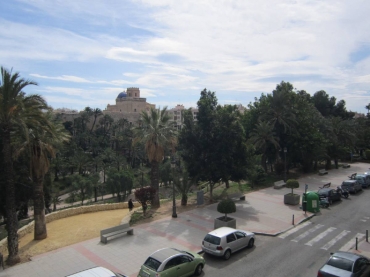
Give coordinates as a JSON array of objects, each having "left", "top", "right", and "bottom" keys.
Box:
[{"left": 33, "top": 177, "right": 47, "bottom": 240}]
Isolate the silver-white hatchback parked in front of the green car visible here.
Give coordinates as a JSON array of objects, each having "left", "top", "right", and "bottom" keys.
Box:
[{"left": 202, "top": 227, "right": 256, "bottom": 260}]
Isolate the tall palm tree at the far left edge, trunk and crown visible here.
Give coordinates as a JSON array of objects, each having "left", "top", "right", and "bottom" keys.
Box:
[{"left": 0, "top": 67, "right": 43, "bottom": 265}]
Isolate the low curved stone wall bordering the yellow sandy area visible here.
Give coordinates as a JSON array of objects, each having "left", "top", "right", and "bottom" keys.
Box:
[{"left": 0, "top": 202, "right": 128, "bottom": 257}]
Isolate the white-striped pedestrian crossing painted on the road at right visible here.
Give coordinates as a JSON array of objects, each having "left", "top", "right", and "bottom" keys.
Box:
[{"left": 278, "top": 221, "right": 365, "bottom": 251}]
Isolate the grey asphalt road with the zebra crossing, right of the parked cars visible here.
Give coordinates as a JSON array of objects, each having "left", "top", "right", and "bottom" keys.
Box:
[{"left": 204, "top": 189, "right": 370, "bottom": 277}]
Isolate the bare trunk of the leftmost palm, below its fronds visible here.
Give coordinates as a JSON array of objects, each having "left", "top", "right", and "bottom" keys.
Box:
[{"left": 3, "top": 126, "right": 20, "bottom": 265}]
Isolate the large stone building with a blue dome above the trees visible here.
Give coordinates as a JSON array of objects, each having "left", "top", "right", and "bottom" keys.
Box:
[{"left": 103, "top": 88, "right": 155, "bottom": 123}]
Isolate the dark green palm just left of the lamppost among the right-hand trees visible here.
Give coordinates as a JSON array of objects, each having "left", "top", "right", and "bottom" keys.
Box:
[{"left": 249, "top": 121, "right": 279, "bottom": 171}]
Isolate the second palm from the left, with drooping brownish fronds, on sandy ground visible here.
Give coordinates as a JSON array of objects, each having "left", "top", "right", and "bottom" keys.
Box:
[{"left": 19, "top": 112, "right": 69, "bottom": 240}]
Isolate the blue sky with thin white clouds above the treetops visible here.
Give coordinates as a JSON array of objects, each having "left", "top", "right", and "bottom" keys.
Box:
[{"left": 0, "top": 0, "right": 370, "bottom": 113}]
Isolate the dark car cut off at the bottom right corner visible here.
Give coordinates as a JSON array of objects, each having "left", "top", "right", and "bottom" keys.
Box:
[{"left": 317, "top": 251, "right": 370, "bottom": 277}]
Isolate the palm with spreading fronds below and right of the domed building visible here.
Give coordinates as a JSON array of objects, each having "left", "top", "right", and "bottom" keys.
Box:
[{"left": 134, "top": 107, "right": 177, "bottom": 207}]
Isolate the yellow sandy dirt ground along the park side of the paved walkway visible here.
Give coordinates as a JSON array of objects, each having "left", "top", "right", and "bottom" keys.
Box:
[{"left": 14, "top": 197, "right": 201, "bottom": 262}]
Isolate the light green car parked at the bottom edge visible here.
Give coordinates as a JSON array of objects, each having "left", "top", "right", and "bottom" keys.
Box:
[{"left": 138, "top": 248, "right": 206, "bottom": 277}]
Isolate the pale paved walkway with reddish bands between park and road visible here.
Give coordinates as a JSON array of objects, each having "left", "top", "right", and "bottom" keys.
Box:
[{"left": 0, "top": 163, "right": 370, "bottom": 277}]
